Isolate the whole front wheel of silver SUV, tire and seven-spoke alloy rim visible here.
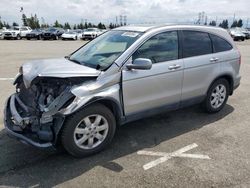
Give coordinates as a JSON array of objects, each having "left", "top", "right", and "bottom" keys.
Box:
[{"left": 61, "top": 104, "right": 116, "bottom": 157}]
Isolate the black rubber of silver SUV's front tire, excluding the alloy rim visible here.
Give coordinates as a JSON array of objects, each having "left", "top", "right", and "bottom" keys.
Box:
[{"left": 61, "top": 104, "right": 116, "bottom": 157}]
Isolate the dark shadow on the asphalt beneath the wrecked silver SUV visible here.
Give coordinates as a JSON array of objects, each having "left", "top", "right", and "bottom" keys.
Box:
[{"left": 0, "top": 105, "right": 234, "bottom": 187}]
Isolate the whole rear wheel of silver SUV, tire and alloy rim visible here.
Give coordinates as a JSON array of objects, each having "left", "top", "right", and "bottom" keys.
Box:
[{"left": 203, "top": 79, "right": 229, "bottom": 113}]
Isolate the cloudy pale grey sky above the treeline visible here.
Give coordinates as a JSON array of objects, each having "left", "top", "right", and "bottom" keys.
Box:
[{"left": 0, "top": 0, "right": 250, "bottom": 26}]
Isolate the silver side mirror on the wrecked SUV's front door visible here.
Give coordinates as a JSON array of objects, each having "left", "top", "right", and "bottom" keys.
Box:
[{"left": 126, "top": 58, "right": 152, "bottom": 70}]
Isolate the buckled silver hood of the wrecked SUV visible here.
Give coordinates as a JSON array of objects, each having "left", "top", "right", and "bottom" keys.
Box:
[{"left": 22, "top": 58, "right": 101, "bottom": 88}]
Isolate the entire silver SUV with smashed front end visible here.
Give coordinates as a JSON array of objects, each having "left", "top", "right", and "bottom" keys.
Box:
[{"left": 4, "top": 25, "right": 241, "bottom": 157}]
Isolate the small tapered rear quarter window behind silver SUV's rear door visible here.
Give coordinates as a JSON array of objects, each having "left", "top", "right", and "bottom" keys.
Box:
[{"left": 210, "top": 34, "right": 233, "bottom": 53}]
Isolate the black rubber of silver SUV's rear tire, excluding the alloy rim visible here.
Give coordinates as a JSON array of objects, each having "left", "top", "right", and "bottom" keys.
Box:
[{"left": 202, "top": 78, "right": 229, "bottom": 113}]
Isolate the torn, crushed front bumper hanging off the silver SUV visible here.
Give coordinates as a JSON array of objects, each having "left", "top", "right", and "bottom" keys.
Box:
[{"left": 4, "top": 94, "right": 53, "bottom": 148}]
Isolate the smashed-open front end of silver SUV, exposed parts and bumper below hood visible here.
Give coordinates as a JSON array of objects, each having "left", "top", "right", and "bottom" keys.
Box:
[{"left": 4, "top": 75, "right": 96, "bottom": 148}]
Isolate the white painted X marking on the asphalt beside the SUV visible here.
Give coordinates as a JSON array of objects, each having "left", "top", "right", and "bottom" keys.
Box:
[{"left": 137, "top": 143, "right": 210, "bottom": 170}]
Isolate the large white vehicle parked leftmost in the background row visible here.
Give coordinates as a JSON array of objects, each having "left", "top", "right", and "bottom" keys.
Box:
[{"left": 3, "top": 26, "right": 32, "bottom": 40}]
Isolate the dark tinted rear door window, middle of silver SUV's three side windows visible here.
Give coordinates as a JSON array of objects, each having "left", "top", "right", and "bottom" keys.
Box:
[{"left": 182, "top": 31, "right": 213, "bottom": 58}]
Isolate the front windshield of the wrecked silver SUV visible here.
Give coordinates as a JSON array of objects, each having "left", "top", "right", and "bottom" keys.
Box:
[{"left": 69, "top": 31, "right": 142, "bottom": 70}]
